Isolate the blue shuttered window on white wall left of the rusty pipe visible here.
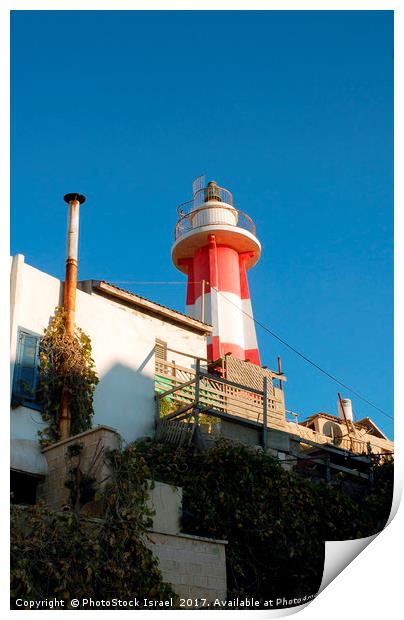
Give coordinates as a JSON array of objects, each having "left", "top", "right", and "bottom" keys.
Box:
[{"left": 13, "top": 330, "right": 39, "bottom": 408}]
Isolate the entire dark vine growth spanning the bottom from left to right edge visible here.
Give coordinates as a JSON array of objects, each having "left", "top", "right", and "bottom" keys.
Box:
[{"left": 11, "top": 441, "right": 393, "bottom": 601}]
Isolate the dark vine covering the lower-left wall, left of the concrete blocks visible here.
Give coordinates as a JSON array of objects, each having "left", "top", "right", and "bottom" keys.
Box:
[{"left": 11, "top": 444, "right": 176, "bottom": 609}]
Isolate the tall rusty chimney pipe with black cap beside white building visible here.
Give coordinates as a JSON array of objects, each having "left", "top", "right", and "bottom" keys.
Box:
[{"left": 59, "top": 193, "right": 86, "bottom": 439}]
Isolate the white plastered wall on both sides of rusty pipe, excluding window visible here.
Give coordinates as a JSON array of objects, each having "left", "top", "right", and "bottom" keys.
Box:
[{"left": 11, "top": 255, "right": 206, "bottom": 458}]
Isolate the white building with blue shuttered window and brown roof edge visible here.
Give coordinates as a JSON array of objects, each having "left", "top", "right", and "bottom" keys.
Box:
[{"left": 10, "top": 254, "right": 212, "bottom": 492}]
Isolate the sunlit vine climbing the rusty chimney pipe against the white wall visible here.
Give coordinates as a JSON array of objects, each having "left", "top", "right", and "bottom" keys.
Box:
[{"left": 39, "top": 307, "right": 98, "bottom": 446}]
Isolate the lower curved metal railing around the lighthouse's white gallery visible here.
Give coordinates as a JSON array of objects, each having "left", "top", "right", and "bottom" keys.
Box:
[{"left": 174, "top": 201, "right": 256, "bottom": 240}]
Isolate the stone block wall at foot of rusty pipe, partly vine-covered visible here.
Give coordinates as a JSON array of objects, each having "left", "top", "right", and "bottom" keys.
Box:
[{"left": 38, "top": 426, "right": 120, "bottom": 510}]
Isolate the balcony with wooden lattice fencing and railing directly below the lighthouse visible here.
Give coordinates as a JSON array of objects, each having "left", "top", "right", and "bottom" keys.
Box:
[{"left": 155, "top": 348, "right": 286, "bottom": 447}]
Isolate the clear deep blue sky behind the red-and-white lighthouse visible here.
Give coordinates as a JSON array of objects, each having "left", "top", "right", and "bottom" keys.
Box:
[{"left": 11, "top": 11, "right": 393, "bottom": 435}]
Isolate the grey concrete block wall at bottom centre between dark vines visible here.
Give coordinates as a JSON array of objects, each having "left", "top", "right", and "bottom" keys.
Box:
[{"left": 147, "top": 531, "right": 227, "bottom": 602}]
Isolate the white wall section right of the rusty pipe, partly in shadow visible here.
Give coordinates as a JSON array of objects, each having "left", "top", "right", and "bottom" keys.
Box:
[{"left": 76, "top": 280, "right": 206, "bottom": 441}]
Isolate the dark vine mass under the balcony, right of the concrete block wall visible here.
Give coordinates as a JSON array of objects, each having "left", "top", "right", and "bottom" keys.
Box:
[{"left": 130, "top": 440, "right": 393, "bottom": 600}]
